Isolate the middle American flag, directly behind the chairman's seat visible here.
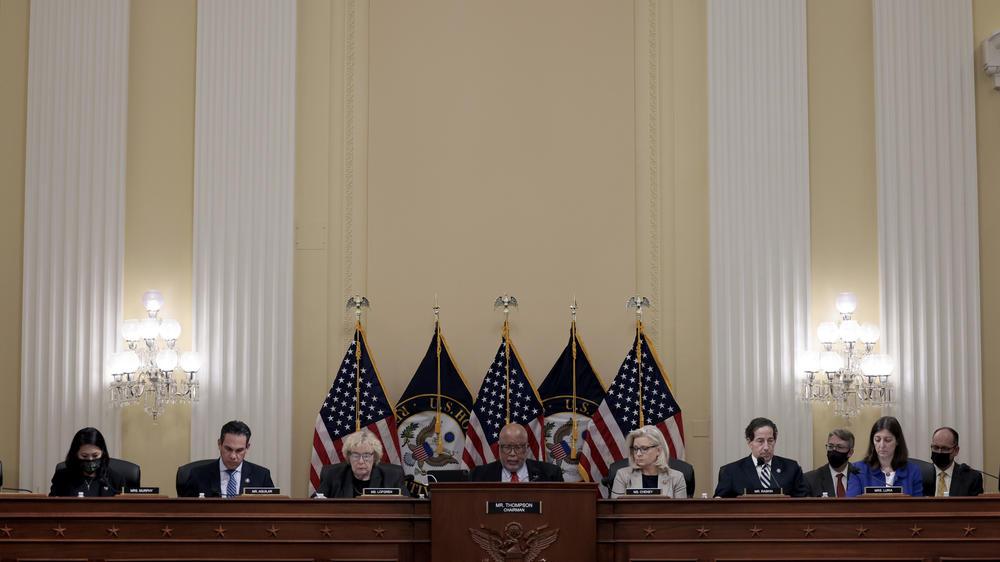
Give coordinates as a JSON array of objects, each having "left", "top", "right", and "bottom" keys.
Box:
[{"left": 462, "top": 332, "right": 545, "bottom": 468}]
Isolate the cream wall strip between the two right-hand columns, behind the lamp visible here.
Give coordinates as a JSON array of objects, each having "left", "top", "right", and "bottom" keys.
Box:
[{"left": 799, "top": 0, "right": 881, "bottom": 470}]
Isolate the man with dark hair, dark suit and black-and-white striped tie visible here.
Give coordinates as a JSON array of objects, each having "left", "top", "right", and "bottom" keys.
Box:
[{"left": 715, "top": 418, "right": 809, "bottom": 498}]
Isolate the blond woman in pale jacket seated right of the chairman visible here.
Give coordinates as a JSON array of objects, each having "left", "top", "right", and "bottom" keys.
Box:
[{"left": 611, "top": 425, "right": 687, "bottom": 498}]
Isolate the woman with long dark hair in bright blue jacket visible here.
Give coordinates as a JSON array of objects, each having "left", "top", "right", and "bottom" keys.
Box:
[{"left": 847, "top": 416, "right": 924, "bottom": 498}]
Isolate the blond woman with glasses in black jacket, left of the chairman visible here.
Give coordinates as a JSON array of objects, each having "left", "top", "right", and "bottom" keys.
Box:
[{"left": 316, "top": 429, "right": 410, "bottom": 498}]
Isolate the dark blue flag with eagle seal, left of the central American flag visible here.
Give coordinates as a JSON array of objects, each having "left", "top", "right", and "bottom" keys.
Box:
[{"left": 396, "top": 329, "right": 472, "bottom": 497}]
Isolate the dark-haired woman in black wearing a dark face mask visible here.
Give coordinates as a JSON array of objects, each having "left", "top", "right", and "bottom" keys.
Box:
[{"left": 49, "top": 427, "right": 125, "bottom": 497}]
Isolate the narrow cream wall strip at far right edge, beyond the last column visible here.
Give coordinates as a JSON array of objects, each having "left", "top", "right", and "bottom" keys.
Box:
[{"left": 976, "top": 0, "right": 1000, "bottom": 492}]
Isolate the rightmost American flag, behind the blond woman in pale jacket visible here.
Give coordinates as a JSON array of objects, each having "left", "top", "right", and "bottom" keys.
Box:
[{"left": 580, "top": 327, "right": 684, "bottom": 496}]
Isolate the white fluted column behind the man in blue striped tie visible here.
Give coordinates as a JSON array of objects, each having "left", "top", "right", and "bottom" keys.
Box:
[{"left": 191, "top": 0, "right": 296, "bottom": 490}]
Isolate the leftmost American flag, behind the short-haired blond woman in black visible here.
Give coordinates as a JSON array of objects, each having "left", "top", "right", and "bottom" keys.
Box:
[{"left": 309, "top": 324, "right": 401, "bottom": 495}]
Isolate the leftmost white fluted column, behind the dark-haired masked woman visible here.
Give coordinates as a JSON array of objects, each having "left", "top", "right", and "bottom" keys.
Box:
[{"left": 20, "top": 0, "right": 129, "bottom": 493}]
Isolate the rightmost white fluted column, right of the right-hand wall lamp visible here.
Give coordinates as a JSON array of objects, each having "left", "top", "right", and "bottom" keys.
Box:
[{"left": 874, "top": 0, "right": 983, "bottom": 468}]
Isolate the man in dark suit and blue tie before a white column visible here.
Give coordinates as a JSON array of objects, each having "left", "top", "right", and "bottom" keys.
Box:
[{"left": 183, "top": 420, "right": 274, "bottom": 498}]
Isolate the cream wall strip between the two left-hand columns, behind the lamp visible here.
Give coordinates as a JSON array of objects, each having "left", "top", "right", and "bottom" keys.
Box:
[{"left": 119, "top": 0, "right": 197, "bottom": 495}]
